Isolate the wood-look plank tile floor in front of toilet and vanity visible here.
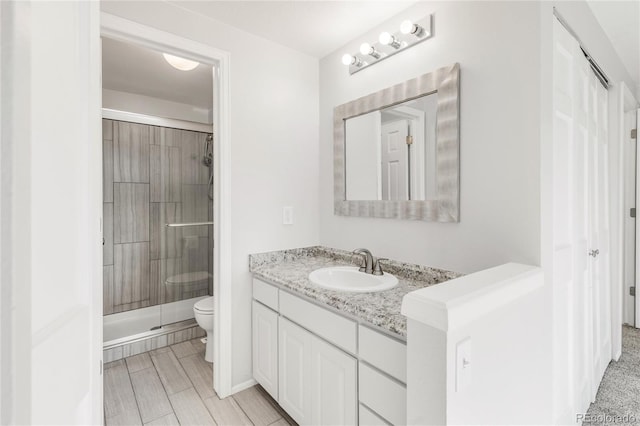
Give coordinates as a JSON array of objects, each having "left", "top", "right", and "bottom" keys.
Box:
[{"left": 104, "top": 339, "right": 295, "bottom": 426}]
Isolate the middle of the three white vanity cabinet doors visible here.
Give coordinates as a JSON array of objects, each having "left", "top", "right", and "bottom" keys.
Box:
[{"left": 278, "top": 317, "right": 313, "bottom": 425}]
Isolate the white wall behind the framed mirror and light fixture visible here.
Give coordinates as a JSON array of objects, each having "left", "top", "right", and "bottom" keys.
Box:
[{"left": 320, "top": 2, "right": 540, "bottom": 272}]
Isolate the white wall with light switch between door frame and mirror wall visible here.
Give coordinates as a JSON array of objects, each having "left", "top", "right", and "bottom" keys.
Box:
[{"left": 102, "top": 1, "right": 319, "bottom": 392}]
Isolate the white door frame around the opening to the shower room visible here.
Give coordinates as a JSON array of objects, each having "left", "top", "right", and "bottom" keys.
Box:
[{"left": 102, "top": 12, "right": 233, "bottom": 398}]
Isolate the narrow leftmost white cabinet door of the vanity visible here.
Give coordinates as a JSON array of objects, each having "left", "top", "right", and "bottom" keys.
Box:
[{"left": 252, "top": 300, "right": 278, "bottom": 399}]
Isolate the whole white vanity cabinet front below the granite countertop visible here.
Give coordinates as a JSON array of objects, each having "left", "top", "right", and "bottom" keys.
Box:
[{"left": 253, "top": 279, "right": 406, "bottom": 425}]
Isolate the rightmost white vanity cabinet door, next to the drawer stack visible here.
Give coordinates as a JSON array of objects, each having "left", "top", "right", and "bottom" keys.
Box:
[{"left": 311, "top": 336, "right": 358, "bottom": 425}]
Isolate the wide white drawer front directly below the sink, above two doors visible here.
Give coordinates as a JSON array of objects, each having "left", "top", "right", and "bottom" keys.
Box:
[{"left": 280, "top": 291, "right": 358, "bottom": 354}]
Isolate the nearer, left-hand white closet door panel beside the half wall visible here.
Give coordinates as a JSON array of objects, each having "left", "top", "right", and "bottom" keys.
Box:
[{"left": 552, "top": 17, "right": 592, "bottom": 413}]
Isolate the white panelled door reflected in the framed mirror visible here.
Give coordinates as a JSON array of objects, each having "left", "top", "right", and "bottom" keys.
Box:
[{"left": 382, "top": 120, "right": 409, "bottom": 200}]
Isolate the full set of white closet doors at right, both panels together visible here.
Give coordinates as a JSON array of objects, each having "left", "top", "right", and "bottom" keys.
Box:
[{"left": 553, "top": 17, "right": 611, "bottom": 420}]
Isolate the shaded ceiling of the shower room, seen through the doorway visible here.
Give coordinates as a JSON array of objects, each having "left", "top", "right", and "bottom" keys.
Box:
[{"left": 102, "top": 38, "right": 213, "bottom": 109}]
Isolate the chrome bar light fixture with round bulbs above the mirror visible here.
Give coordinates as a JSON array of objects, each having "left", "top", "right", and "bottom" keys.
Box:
[{"left": 342, "top": 15, "right": 433, "bottom": 74}]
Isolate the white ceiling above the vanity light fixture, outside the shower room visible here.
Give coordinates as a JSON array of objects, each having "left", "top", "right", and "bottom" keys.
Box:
[{"left": 169, "top": 0, "right": 417, "bottom": 58}]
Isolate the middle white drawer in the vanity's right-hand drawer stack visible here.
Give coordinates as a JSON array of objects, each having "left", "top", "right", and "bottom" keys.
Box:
[{"left": 358, "top": 362, "right": 407, "bottom": 425}]
